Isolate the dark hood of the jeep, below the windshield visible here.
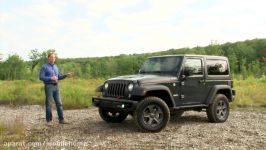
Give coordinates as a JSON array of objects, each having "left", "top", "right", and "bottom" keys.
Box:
[{"left": 109, "top": 74, "right": 177, "bottom": 84}]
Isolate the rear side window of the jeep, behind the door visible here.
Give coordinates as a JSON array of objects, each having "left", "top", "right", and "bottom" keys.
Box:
[{"left": 206, "top": 59, "right": 229, "bottom": 75}]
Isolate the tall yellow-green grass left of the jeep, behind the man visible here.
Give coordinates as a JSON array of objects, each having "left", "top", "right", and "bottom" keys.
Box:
[{"left": 0, "top": 79, "right": 103, "bottom": 109}]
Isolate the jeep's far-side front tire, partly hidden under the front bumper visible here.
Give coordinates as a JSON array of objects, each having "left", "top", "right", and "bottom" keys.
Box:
[{"left": 99, "top": 108, "right": 128, "bottom": 123}]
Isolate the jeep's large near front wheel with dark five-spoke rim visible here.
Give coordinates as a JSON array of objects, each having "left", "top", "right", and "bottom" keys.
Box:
[{"left": 134, "top": 97, "right": 170, "bottom": 132}]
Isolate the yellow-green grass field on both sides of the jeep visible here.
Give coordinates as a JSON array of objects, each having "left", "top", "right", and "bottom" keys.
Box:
[{"left": 0, "top": 76, "right": 266, "bottom": 109}]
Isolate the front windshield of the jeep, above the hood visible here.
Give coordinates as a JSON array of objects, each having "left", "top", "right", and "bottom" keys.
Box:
[{"left": 139, "top": 56, "right": 182, "bottom": 75}]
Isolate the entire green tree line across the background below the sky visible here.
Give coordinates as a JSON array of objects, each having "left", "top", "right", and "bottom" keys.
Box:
[{"left": 0, "top": 39, "right": 266, "bottom": 80}]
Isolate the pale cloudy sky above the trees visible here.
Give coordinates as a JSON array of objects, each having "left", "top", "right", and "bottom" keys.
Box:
[{"left": 0, "top": 0, "right": 266, "bottom": 60}]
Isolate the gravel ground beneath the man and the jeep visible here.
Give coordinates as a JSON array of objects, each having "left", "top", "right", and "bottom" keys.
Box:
[{"left": 0, "top": 105, "right": 266, "bottom": 150}]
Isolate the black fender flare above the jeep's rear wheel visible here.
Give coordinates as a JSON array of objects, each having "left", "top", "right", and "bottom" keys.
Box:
[{"left": 206, "top": 85, "right": 233, "bottom": 104}]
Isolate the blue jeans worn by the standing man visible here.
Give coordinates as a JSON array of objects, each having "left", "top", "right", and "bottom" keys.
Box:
[{"left": 44, "top": 84, "right": 64, "bottom": 122}]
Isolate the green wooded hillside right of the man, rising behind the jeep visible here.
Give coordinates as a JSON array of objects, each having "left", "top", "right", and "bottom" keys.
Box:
[{"left": 57, "top": 39, "right": 266, "bottom": 78}]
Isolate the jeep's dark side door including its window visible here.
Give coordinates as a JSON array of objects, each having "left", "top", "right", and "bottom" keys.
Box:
[{"left": 180, "top": 57, "right": 208, "bottom": 105}]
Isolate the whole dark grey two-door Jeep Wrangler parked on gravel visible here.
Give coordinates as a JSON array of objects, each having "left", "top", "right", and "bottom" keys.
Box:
[{"left": 92, "top": 55, "right": 235, "bottom": 132}]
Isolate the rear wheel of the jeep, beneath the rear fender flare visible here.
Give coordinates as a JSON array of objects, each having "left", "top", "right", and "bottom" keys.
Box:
[{"left": 206, "top": 94, "right": 230, "bottom": 123}]
